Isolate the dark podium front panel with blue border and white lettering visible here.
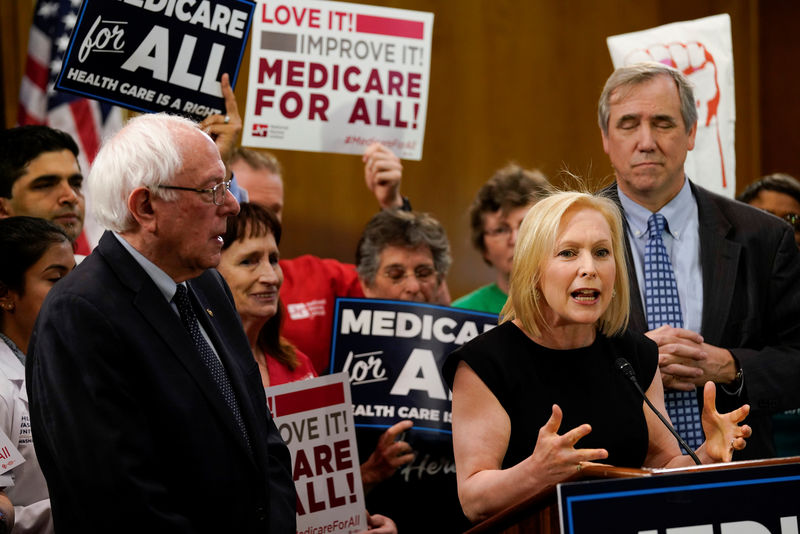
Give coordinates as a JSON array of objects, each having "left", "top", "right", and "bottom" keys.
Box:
[{"left": 558, "top": 463, "right": 800, "bottom": 534}]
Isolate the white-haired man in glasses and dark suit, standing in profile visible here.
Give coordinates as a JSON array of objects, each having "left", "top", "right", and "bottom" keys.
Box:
[{"left": 27, "top": 114, "right": 295, "bottom": 533}]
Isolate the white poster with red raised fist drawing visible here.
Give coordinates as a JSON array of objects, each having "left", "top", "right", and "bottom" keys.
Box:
[{"left": 607, "top": 15, "right": 736, "bottom": 198}]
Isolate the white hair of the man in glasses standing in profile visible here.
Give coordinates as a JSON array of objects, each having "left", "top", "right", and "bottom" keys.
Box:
[{"left": 87, "top": 113, "right": 205, "bottom": 232}]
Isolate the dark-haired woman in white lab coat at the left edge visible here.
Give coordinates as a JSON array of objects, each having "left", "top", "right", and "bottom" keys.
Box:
[{"left": 0, "top": 217, "right": 75, "bottom": 532}]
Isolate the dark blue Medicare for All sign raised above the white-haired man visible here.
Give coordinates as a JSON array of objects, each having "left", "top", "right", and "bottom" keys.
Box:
[{"left": 56, "top": 0, "right": 255, "bottom": 121}]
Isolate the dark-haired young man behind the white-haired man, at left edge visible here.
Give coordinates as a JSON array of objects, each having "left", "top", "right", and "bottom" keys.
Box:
[{"left": 0, "top": 125, "right": 89, "bottom": 255}]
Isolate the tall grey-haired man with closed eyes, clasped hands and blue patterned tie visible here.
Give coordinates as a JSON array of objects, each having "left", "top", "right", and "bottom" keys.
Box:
[{"left": 598, "top": 63, "right": 800, "bottom": 459}]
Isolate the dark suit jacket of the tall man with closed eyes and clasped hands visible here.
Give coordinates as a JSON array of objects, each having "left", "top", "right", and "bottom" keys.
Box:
[{"left": 608, "top": 182, "right": 800, "bottom": 460}]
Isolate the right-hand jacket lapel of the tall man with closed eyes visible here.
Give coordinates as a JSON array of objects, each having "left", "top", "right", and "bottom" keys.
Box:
[{"left": 691, "top": 183, "right": 742, "bottom": 345}]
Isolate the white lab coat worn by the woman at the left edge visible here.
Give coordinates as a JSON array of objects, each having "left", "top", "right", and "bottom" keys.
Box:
[{"left": 0, "top": 340, "right": 53, "bottom": 534}]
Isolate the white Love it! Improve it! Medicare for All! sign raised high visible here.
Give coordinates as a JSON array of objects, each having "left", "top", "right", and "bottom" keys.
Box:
[{"left": 242, "top": 0, "right": 433, "bottom": 160}]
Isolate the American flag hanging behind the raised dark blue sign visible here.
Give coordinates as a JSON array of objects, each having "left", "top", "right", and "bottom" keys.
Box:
[{"left": 17, "top": 0, "right": 122, "bottom": 253}]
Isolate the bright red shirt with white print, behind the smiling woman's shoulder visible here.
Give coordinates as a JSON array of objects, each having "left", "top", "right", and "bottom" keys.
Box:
[{"left": 280, "top": 255, "right": 364, "bottom": 374}]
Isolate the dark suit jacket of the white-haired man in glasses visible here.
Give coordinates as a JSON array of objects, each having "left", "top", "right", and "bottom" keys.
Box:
[{"left": 26, "top": 233, "right": 295, "bottom": 534}]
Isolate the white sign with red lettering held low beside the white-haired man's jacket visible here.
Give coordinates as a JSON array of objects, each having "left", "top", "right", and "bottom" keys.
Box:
[{"left": 266, "top": 373, "right": 367, "bottom": 534}]
